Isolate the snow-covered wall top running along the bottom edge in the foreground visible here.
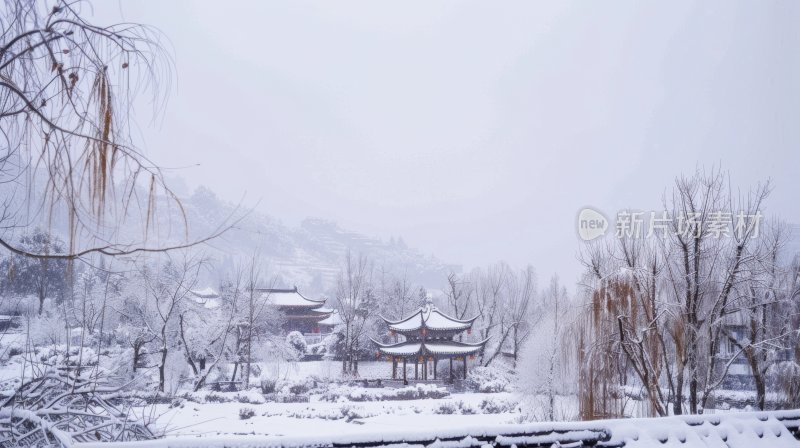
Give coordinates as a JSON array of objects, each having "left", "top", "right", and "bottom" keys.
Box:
[{"left": 75, "top": 410, "right": 800, "bottom": 448}]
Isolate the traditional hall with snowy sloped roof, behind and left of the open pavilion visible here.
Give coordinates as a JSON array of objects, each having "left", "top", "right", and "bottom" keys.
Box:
[{"left": 257, "top": 286, "right": 333, "bottom": 334}]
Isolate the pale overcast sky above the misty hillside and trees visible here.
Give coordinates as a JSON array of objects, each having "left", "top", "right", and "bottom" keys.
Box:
[{"left": 95, "top": 0, "right": 800, "bottom": 280}]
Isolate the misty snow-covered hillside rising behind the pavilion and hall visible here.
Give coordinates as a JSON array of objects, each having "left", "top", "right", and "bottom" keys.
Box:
[{"left": 182, "top": 187, "right": 460, "bottom": 294}]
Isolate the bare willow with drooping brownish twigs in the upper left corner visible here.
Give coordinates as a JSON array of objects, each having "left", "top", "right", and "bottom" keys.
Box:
[{"left": 0, "top": 0, "right": 225, "bottom": 259}]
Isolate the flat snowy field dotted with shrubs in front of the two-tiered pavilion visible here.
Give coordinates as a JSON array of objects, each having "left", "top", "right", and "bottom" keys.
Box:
[{"left": 123, "top": 361, "right": 532, "bottom": 437}]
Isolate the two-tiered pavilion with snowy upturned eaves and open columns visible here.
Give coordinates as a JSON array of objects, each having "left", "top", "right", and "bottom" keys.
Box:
[{"left": 372, "top": 302, "right": 488, "bottom": 384}]
